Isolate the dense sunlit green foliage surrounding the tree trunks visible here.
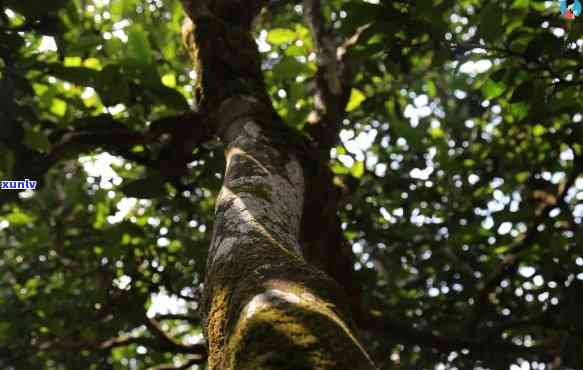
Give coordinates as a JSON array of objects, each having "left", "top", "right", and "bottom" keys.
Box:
[{"left": 0, "top": 0, "right": 583, "bottom": 370}]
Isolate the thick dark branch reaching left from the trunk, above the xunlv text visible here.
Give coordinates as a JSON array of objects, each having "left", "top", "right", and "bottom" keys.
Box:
[{"left": 0, "top": 112, "right": 212, "bottom": 210}]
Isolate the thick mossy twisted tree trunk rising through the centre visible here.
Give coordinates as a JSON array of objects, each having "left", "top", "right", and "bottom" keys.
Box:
[{"left": 183, "top": 0, "right": 374, "bottom": 370}]
